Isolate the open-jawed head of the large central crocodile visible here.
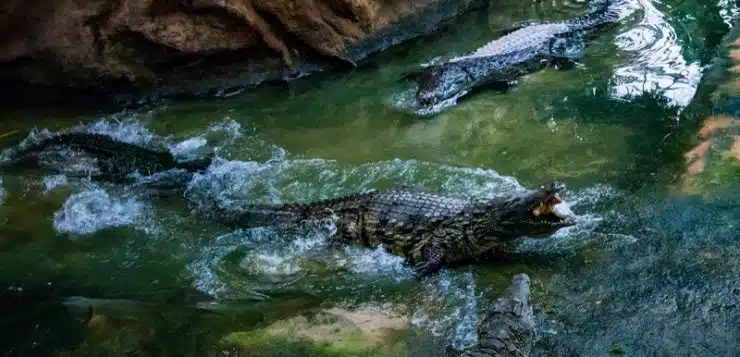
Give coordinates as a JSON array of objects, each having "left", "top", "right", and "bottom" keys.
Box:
[{"left": 489, "top": 182, "right": 578, "bottom": 239}]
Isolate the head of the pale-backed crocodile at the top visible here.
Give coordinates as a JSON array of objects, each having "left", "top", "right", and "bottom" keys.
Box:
[{"left": 416, "top": 64, "right": 471, "bottom": 107}]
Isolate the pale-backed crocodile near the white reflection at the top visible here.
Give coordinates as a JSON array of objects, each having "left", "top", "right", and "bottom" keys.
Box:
[{"left": 416, "top": 0, "right": 619, "bottom": 107}]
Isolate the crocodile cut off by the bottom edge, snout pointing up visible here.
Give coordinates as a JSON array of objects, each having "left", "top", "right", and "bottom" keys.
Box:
[{"left": 459, "top": 273, "right": 536, "bottom": 357}]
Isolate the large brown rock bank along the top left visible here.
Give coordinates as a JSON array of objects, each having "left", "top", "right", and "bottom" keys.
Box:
[{"left": 0, "top": 0, "right": 487, "bottom": 105}]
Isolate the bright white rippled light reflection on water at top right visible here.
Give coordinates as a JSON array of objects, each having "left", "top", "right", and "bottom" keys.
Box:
[{"left": 611, "top": 0, "right": 702, "bottom": 108}]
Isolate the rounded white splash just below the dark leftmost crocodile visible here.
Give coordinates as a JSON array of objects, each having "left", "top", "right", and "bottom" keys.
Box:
[{"left": 53, "top": 185, "right": 153, "bottom": 238}]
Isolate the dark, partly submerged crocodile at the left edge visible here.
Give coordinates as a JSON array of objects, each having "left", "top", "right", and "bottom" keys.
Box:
[{"left": 0, "top": 132, "right": 213, "bottom": 183}]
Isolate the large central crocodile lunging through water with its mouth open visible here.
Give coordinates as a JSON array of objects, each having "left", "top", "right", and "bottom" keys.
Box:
[{"left": 208, "top": 182, "right": 579, "bottom": 277}]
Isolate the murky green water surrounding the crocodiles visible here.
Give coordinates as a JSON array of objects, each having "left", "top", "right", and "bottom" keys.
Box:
[{"left": 0, "top": 0, "right": 740, "bottom": 356}]
